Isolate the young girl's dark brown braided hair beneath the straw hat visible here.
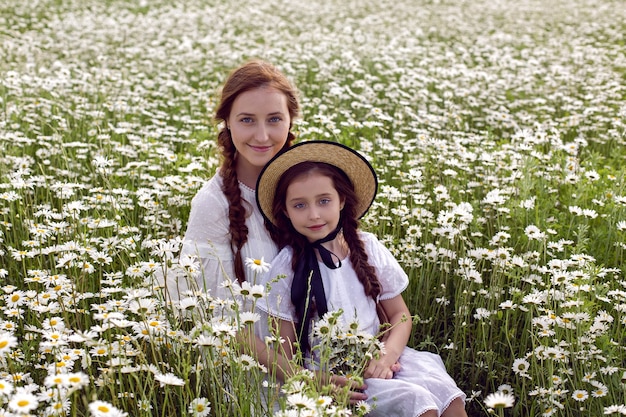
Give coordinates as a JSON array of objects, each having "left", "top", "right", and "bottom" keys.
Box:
[{"left": 272, "top": 162, "right": 381, "bottom": 301}]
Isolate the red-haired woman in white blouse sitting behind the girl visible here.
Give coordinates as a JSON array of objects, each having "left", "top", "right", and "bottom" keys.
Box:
[{"left": 167, "top": 60, "right": 300, "bottom": 300}]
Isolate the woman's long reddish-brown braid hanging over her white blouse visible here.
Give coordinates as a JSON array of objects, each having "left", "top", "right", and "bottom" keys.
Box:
[{"left": 218, "top": 129, "right": 248, "bottom": 283}]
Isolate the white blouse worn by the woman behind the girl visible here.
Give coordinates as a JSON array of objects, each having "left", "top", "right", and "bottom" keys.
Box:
[{"left": 168, "top": 172, "right": 278, "bottom": 299}]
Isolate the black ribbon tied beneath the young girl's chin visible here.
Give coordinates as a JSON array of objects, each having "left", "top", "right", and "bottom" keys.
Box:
[{"left": 291, "top": 221, "right": 341, "bottom": 354}]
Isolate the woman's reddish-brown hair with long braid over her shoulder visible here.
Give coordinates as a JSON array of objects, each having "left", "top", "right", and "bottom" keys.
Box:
[{"left": 215, "top": 60, "right": 300, "bottom": 283}]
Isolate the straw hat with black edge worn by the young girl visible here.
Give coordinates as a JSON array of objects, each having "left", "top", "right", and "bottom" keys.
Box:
[{"left": 256, "top": 140, "right": 378, "bottom": 224}]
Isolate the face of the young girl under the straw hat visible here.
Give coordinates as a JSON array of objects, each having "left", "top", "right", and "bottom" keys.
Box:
[{"left": 285, "top": 171, "right": 344, "bottom": 242}]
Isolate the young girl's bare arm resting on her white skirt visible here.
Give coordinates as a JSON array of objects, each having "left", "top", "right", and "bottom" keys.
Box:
[{"left": 364, "top": 295, "right": 413, "bottom": 379}]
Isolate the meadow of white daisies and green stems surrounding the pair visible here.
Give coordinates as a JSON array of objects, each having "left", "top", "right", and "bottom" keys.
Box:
[{"left": 0, "top": 0, "right": 626, "bottom": 417}]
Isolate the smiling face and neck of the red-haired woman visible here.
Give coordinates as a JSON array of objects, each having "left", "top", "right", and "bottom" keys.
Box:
[{"left": 226, "top": 87, "right": 291, "bottom": 185}]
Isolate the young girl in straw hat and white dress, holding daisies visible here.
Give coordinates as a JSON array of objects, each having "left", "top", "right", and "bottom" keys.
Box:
[{"left": 256, "top": 141, "right": 467, "bottom": 417}]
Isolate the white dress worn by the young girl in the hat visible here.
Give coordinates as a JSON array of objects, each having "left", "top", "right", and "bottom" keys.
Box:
[{"left": 257, "top": 232, "right": 465, "bottom": 417}]
